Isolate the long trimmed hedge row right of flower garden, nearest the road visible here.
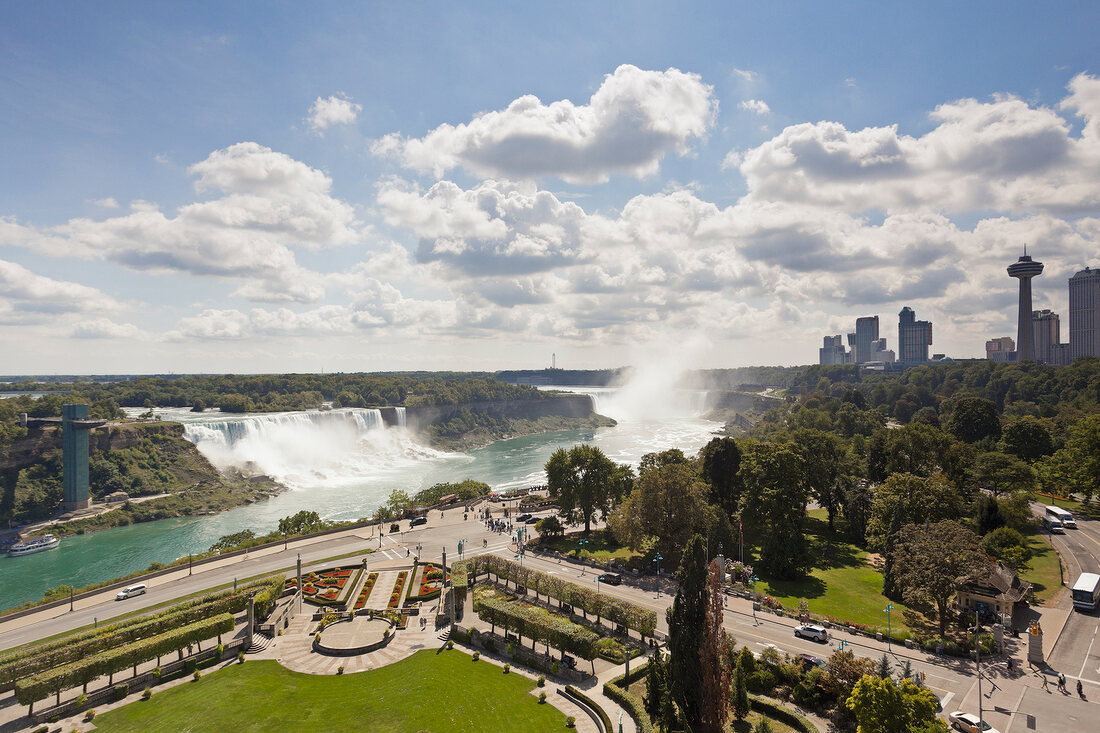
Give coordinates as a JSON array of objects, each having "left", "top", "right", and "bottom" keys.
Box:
[{"left": 452, "top": 555, "right": 657, "bottom": 636}]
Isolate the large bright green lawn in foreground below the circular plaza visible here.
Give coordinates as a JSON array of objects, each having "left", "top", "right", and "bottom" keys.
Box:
[{"left": 96, "top": 649, "right": 565, "bottom": 733}]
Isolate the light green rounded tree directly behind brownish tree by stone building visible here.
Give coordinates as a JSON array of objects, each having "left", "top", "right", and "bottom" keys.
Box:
[{"left": 867, "top": 473, "right": 963, "bottom": 551}]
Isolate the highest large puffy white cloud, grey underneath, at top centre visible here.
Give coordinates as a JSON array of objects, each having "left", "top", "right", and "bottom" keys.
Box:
[{"left": 372, "top": 65, "right": 717, "bottom": 184}]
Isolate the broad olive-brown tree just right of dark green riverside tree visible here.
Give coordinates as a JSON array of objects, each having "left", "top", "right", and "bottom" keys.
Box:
[{"left": 608, "top": 463, "right": 710, "bottom": 558}]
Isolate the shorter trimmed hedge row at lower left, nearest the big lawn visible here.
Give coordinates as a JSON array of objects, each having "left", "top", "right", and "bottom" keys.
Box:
[{"left": 15, "top": 613, "right": 233, "bottom": 705}]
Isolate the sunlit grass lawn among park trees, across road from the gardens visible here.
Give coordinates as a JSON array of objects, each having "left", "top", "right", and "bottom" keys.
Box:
[{"left": 757, "top": 510, "right": 906, "bottom": 636}]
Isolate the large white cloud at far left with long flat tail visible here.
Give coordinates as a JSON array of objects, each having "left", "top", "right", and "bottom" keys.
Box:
[{"left": 7, "top": 142, "right": 362, "bottom": 303}]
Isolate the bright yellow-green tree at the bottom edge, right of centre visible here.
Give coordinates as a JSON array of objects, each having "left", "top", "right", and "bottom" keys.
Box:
[{"left": 845, "top": 675, "right": 947, "bottom": 733}]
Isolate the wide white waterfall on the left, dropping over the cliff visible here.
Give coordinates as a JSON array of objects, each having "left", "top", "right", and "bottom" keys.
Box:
[{"left": 184, "top": 407, "right": 440, "bottom": 488}]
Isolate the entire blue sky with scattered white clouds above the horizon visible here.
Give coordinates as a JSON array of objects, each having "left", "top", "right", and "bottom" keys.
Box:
[{"left": 0, "top": 1, "right": 1100, "bottom": 374}]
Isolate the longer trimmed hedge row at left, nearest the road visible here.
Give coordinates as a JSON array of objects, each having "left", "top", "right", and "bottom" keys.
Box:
[{"left": 0, "top": 576, "right": 283, "bottom": 685}]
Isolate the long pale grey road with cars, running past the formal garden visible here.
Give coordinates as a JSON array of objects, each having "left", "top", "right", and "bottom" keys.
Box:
[{"left": 0, "top": 505, "right": 1100, "bottom": 733}]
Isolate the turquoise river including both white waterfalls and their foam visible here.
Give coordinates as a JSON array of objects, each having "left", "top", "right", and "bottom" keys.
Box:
[{"left": 0, "top": 387, "right": 722, "bottom": 609}]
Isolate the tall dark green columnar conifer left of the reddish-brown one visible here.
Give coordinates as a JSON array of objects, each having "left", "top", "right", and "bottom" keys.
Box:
[{"left": 666, "top": 535, "right": 707, "bottom": 730}]
